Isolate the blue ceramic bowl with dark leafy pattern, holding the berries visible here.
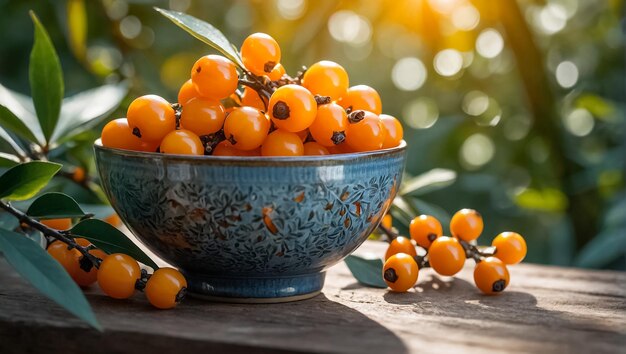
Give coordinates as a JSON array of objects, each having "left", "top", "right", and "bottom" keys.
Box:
[{"left": 95, "top": 142, "right": 406, "bottom": 302}]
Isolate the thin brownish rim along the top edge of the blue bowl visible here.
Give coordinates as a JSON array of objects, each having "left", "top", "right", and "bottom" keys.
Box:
[{"left": 93, "top": 139, "right": 407, "bottom": 165}]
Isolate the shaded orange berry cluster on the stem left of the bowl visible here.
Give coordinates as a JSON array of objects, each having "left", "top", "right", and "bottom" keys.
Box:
[{"left": 41, "top": 219, "right": 187, "bottom": 309}]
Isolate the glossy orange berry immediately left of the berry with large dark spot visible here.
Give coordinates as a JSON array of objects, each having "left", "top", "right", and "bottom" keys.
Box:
[{"left": 224, "top": 107, "right": 270, "bottom": 150}]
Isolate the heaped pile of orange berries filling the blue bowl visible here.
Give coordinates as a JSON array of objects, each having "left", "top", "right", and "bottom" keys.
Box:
[{"left": 102, "top": 33, "right": 403, "bottom": 156}]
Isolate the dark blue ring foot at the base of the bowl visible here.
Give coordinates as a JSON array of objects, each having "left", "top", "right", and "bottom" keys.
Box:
[{"left": 185, "top": 272, "right": 326, "bottom": 303}]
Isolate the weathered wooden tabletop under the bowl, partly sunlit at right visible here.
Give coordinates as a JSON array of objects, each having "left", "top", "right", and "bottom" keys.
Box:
[{"left": 0, "top": 242, "right": 626, "bottom": 354}]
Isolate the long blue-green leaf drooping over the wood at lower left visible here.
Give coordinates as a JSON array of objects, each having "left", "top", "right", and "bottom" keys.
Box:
[{"left": 0, "top": 229, "right": 102, "bottom": 330}]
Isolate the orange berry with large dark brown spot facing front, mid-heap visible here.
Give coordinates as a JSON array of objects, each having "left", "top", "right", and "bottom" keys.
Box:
[{"left": 268, "top": 85, "right": 317, "bottom": 133}]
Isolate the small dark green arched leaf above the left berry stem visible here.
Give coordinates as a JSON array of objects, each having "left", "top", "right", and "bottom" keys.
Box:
[{"left": 26, "top": 193, "right": 85, "bottom": 219}]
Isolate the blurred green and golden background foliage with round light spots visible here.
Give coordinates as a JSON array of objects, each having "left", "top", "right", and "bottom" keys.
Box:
[{"left": 0, "top": 0, "right": 626, "bottom": 269}]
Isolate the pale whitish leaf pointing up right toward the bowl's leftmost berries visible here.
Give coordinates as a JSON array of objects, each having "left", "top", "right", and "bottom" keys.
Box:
[{"left": 50, "top": 83, "right": 128, "bottom": 144}]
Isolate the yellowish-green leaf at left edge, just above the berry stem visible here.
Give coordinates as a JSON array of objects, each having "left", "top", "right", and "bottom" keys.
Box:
[{"left": 0, "top": 161, "right": 61, "bottom": 200}]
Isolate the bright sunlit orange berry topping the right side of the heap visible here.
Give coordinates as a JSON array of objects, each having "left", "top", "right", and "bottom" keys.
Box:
[{"left": 302, "top": 60, "right": 350, "bottom": 101}]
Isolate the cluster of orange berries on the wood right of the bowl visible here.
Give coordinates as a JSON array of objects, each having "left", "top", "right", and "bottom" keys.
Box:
[{"left": 383, "top": 209, "right": 526, "bottom": 295}]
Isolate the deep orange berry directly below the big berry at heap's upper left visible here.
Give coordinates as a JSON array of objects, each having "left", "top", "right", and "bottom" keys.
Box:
[{"left": 180, "top": 97, "right": 226, "bottom": 136}]
